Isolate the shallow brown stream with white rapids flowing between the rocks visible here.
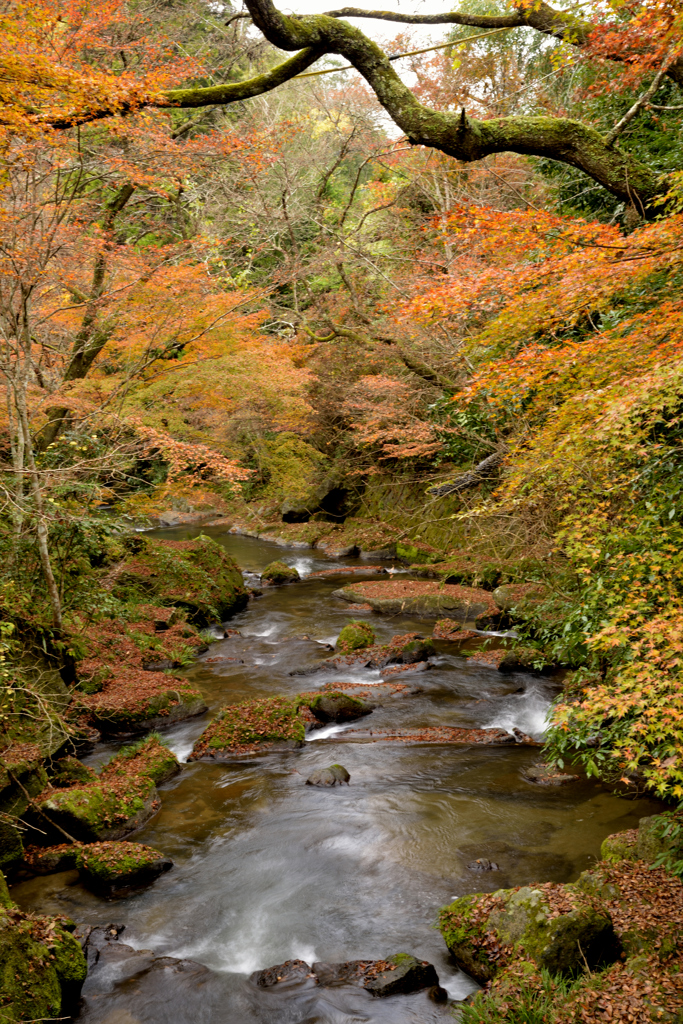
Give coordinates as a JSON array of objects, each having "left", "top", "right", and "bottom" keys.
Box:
[{"left": 12, "top": 528, "right": 659, "bottom": 1024}]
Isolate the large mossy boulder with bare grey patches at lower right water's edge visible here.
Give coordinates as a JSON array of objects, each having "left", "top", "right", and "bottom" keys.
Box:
[{"left": 439, "top": 883, "right": 621, "bottom": 984}]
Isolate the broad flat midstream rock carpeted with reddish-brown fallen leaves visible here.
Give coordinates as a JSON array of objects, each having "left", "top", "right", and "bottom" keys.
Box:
[{"left": 333, "top": 580, "right": 501, "bottom": 626}]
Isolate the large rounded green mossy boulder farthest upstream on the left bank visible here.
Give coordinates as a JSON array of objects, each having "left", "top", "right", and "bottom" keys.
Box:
[{"left": 110, "top": 535, "right": 248, "bottom": 626}]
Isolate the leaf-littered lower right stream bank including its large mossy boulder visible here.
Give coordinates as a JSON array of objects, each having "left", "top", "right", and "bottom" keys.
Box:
[{"left": 439, "top": 816, "right": 683, "bottom": 1024}]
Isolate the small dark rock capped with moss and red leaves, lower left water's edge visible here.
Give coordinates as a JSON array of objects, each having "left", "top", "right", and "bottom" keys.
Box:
[{"left": 76, "top": 843, "right": 173, "bottom": 893}]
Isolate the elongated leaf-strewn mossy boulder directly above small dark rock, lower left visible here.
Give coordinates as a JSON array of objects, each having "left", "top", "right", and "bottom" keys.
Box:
[{"left": 32, "top": 735, "right": 179, "bottom": 842}]
